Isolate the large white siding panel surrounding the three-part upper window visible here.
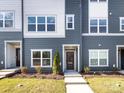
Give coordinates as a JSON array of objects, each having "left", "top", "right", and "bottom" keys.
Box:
[{"left": 24, "top": 0, "right": 65, "bottom": 38}]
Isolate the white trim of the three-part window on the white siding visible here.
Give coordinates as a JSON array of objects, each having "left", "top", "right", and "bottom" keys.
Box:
[{"left": 27, "top": 15, "right": 57, "bottom": 33}]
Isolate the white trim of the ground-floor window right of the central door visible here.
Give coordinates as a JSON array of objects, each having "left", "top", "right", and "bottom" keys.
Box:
[{"left": 88, "top": 49, "right": 109, "bottom": 67}]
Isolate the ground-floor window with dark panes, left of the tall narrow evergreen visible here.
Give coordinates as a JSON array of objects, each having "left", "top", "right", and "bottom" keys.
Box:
[{"left": 31, "top": 50, "right": 52, "bottom": 67}]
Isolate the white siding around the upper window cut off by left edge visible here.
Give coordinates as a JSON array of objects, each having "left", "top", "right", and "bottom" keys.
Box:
[{"left": 0, "top": 0, "right": 22, "bottom": 31}]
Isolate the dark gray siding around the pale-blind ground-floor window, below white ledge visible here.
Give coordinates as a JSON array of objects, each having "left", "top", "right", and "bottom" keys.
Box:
[{"left": 82, "top": 36, "right": 124, "bottom": 70}]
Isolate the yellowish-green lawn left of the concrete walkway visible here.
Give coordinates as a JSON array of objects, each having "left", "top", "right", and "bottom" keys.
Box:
[{"left": 0, "top": 79, "right": 65, "bottom": 93}]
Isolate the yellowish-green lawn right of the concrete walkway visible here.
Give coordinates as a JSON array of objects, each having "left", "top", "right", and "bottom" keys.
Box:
[{"left": 86, "top": 76, "right": 124, "bottom": 93}]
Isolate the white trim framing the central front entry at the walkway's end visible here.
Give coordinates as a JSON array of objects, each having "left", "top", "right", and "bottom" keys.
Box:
[{"left": 62, "top": 44, "right": 80, "bottom": 72}]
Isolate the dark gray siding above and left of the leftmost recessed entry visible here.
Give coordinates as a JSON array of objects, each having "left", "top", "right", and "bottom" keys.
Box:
[{"left": 0, "top": 32, "right": 22, "bottom": 69}]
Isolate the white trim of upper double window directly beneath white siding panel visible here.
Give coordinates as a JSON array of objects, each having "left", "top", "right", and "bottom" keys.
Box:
[{"left": 89, "top": 17, "right": 108, "bottom": 34}]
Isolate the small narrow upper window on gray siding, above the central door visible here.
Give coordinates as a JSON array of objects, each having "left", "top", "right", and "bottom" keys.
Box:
[{"left": 66, "top": 15, "right": 74, "bottom": 30}]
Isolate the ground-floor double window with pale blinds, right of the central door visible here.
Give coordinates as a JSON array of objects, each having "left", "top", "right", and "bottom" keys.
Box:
[{"left": 89, "top": 49, "right": 108, "bottom": 67}]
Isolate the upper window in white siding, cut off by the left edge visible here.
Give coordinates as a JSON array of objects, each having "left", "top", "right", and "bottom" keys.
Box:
[{"left": 0, "top": 12, "right": 14, "bottom": 28}]
